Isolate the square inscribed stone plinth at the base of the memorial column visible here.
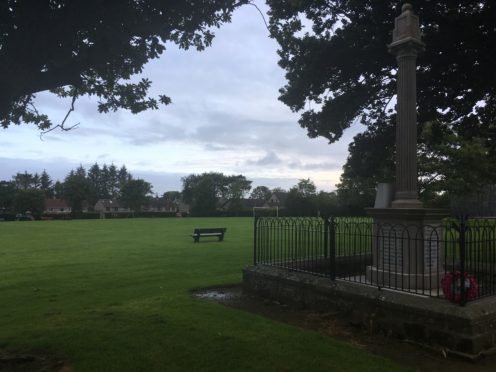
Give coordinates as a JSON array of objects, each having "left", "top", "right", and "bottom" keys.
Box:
[{"left": 366, "top": 208, "right": 448, "bottom": 290}]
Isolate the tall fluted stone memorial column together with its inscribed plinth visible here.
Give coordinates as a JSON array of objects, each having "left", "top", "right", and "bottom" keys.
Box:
[{"left": 366, "top": 4, "right": 447, "bottom": 291}]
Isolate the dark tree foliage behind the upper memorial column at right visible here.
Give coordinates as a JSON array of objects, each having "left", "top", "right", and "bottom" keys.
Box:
[{"left": 268, "top": 0, "right": 496, "bottom": 199}]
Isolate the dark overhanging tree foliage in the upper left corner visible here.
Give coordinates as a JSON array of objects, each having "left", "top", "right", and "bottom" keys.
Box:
[{"left": 0, "top": 0, "right": 244, "bottom": 130}]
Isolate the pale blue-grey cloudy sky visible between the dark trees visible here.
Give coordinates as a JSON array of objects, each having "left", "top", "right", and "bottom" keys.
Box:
[{"left": 0, "top": 4, "right": 359, "bottom": 193}]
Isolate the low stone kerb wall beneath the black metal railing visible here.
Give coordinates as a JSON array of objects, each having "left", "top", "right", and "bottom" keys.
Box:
[{"left": 243, "top": 265, "right": 496, "bottom": 355}]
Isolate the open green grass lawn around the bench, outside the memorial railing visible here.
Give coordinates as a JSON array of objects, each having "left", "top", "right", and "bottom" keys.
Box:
[{"left": 0, "top": 218, "right": 401, "bottom": 371}]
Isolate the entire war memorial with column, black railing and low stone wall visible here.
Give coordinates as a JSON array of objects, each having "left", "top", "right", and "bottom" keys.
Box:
[{"left": 243, "top": 4, "right": 496, "bottom": 358}]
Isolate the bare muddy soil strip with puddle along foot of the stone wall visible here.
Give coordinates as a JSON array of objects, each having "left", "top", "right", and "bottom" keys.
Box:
[{"left": 193, "top": 285, "right": 496, "bottom": 372}]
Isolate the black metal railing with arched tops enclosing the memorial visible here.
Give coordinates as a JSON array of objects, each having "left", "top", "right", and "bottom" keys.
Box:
[{"left": 254, "top": 217, "right": 496, "bottom": 305}]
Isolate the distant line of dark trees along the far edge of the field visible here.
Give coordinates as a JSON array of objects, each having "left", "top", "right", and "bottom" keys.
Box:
[{"left": 0, "top": 163, "right": 373, "bottom": 217}]
